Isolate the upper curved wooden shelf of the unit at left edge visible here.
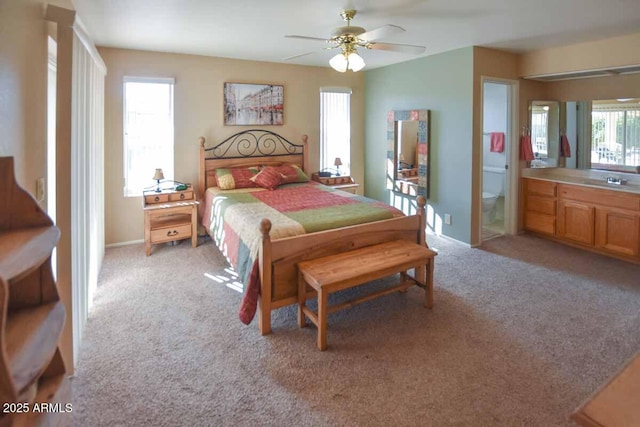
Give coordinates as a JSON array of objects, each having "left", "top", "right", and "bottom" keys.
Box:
[{"left": 0, "top": 226, "right": 60, "bottom": 283}]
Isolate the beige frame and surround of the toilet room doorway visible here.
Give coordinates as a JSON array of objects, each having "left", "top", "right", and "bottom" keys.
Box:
[{"left": 476, "top": 76, "right": 520, "bottom": 244}]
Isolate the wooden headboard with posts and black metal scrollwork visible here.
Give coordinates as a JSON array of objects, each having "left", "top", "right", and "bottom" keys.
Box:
[{"left": 198, "top": 129, "right": 309, "bottom": 200}]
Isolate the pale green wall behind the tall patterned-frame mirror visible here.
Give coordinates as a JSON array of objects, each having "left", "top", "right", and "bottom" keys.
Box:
[{"left": 365, "top": 47, "right": 473, "bottom": 243}]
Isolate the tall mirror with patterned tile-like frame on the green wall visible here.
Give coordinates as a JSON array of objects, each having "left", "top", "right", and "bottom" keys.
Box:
[{"left": 387, "top": 110, "right": 430, "bottom": 197}]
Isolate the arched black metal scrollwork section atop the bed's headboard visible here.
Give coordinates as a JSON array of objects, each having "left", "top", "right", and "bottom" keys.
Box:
[{"left": 205, "top": 129, "right": 304, "bottom": 159}]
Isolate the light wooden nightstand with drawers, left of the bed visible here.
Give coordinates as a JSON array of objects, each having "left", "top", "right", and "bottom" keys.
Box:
[{"left": 143, "top": 187, "right": 200, "bottom": 256}]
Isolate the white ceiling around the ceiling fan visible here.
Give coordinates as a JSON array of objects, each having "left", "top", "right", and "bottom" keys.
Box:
[{"left": 73, "top": 0, "right": 640, "bottom": 69}]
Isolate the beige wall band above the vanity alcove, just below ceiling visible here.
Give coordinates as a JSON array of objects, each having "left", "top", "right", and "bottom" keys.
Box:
[{"left": 518, "top": 33, "right": 640, "bottom": 77}]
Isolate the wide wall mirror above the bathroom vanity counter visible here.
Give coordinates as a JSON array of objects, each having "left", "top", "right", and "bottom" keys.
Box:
[{"left": 529, "top": 98, "right": 640, "bottom": 173}]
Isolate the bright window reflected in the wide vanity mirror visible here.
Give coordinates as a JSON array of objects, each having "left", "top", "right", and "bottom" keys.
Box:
[{"left": 591, "top": 102, "right": 640, "bottom": 172}]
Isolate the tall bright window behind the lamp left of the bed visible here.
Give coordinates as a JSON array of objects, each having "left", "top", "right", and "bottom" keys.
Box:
[{"left": 124, "top": 77, "right": 174, "bottom": 197}]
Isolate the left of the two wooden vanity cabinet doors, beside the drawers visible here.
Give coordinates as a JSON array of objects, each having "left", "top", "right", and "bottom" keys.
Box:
[{"left": 558, "top": 200, "right": 595, "bottom": 246}]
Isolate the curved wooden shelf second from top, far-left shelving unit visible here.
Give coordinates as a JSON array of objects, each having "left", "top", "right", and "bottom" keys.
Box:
[{"left": 4, "top": 301, "right": 65, "bottom": 394}]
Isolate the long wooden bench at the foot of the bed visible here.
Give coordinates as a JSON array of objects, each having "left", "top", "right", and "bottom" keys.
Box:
[{"left": 298, "top": 240, "right": 436, "bottom": 350}]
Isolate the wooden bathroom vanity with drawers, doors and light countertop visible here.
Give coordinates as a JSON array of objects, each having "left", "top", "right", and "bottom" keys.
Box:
[{"left": 522, "top": 169, "right": 640, "bottom": 263}]
